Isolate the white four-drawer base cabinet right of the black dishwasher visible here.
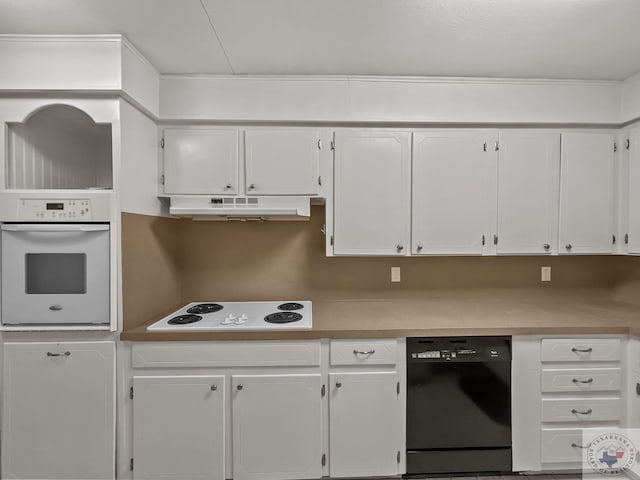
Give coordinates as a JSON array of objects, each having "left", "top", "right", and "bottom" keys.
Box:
[{"left": 512, "top": 336, "right": 633, "bottom": 472}]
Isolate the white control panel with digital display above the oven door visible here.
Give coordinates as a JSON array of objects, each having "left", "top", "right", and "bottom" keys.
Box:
[{"left": 17, "top": 198, "right": 93, "bottom": 222}]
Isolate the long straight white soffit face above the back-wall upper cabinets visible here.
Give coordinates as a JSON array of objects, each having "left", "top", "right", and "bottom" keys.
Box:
[{"left": 160, "top": 76, "right": 621, "bottom": 125}]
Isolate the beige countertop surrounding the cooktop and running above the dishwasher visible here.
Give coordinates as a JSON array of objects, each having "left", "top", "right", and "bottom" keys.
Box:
[{"left": 120, "top": 289, "right": 640, "bottom": 341}]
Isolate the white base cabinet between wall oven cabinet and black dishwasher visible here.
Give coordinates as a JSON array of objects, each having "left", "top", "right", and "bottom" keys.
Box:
[{"left": 126, "top": 339, "right": 406, "bottom": 480}]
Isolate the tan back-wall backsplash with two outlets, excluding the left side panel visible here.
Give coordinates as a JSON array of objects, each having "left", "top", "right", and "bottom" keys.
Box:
[{"left": 177, "top": 207, "right": 634, "bottom": 301}]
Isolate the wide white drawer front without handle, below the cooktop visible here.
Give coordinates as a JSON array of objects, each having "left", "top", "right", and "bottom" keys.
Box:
[{"left": 131, "top": 340, "right": 320, "bottom": 368}]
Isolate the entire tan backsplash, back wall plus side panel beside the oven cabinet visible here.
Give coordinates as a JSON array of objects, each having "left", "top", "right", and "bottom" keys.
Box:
[{"left": 122, "top": 207, "right": 640, "bottom": 328}]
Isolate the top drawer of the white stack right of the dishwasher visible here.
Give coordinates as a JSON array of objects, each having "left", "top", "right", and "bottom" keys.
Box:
[{"left": 541, "top": 338, "right": 620, "bottom": 362}]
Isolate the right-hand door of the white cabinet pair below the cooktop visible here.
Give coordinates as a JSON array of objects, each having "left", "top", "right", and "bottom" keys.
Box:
[{"left": 232, "top": 374, "right": 322, "bottom": 480}]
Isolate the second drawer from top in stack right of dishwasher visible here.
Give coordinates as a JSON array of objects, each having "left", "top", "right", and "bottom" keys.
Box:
[{"left": 542, "top": 368, "right": 620, "bottom": 392}]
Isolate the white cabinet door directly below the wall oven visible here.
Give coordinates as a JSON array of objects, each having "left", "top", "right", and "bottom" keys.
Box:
[{"left": 2, "top": 342, "right": 115, "bottom": 480}]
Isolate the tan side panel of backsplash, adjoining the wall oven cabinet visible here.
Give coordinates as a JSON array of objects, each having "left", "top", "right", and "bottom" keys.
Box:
[{"left": 122, "top": 213, "right": 182, "bottom": 328}]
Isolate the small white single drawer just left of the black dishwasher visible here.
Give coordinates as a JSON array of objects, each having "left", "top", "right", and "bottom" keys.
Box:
[{"left": 331, "top": 339, "right": 398, "bottom": 365}]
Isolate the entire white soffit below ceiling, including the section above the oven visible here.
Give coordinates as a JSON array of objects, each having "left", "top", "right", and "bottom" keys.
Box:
[{"left": 0, "top": 35, "right": 640, "bottom": 126}]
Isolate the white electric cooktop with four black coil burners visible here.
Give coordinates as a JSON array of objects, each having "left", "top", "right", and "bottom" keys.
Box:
[{"left": 147, "top": 300, "right": 312, "bottom": 331}]
